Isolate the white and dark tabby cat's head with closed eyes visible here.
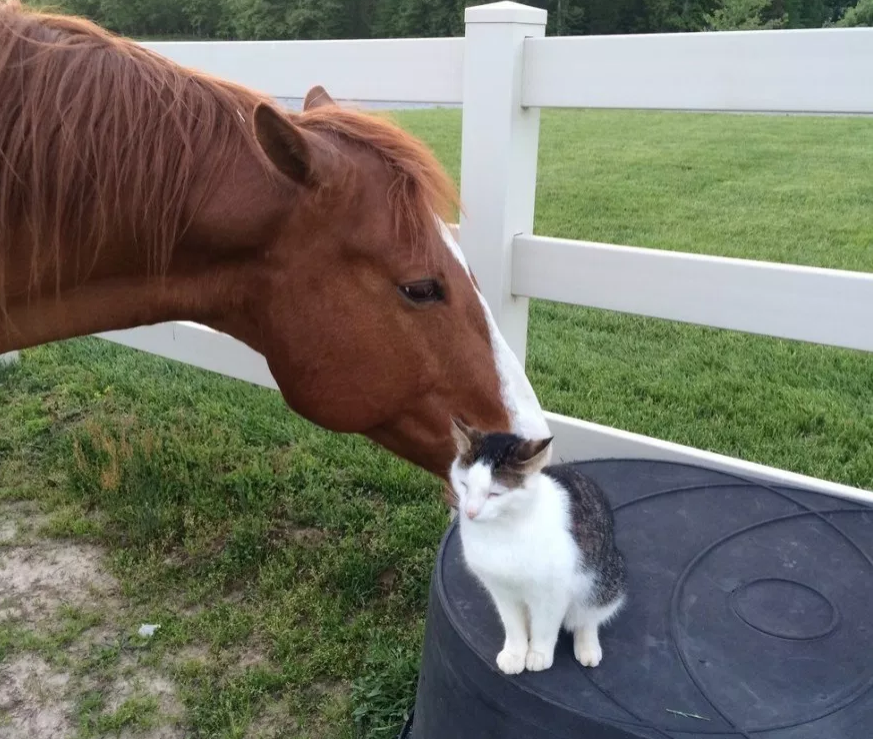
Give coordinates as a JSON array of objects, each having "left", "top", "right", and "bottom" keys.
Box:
[{"left": 449, "top": 418, "right": 552, "bottom": 522}]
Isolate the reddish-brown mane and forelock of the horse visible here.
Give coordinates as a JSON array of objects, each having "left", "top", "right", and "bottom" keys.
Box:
[{"left": 0, "top": 0, "right": 457, "bottom": 310}]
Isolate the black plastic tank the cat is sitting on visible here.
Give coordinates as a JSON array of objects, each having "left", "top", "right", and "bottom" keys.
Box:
[{"left": 401, "top": 460, "right": 873, "bottom": 739}]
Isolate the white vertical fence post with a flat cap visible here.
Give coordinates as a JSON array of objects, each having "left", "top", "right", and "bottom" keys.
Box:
[{"left": 460, "top": 2, "right": 547, "bottom": 365}]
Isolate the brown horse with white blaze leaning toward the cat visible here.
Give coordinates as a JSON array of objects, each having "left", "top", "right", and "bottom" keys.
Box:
[{"left": 0, "top": 2, "right": 548, "bottom": 478}]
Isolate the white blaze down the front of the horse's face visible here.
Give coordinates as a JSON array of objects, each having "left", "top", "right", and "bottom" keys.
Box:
[{"left": 439, "top": 220, "right": 552, "bottom": 446}]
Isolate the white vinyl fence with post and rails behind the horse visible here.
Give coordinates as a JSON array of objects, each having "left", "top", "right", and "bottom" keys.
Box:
[{"left": 80, "top": 2, "right": 873, "bottom": 501}]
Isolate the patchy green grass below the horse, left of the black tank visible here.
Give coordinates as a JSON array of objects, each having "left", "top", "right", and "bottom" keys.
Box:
[{"left": 0, "top": 340, "right": 440, "bottom": 739}]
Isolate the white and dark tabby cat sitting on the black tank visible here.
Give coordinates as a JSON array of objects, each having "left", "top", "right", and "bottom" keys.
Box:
[{"left": 447, "top": 419, "right": 627, "bottom": 675}]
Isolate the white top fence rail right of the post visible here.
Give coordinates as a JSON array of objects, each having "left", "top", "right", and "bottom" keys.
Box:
[{"left": 521, "top": 28, "right": 873, "bottom": 113}]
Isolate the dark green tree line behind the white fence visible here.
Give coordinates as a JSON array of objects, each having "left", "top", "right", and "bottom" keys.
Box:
[{"left": 35, "top": 0, "right": 873, "bottom": 39}]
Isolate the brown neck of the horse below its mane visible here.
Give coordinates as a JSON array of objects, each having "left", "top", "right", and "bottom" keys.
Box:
[{"left": 0, "top": 151, "right": 284, "bottom": 354}]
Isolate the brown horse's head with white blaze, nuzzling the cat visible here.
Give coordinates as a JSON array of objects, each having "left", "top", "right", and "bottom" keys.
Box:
[{"left": 232, "top": 87, "right": 549, "bottom": 477}]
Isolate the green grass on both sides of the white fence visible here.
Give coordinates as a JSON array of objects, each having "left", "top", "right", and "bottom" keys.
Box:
[{"left": 0, "top": 111, "right": 873, "bottom": 739}]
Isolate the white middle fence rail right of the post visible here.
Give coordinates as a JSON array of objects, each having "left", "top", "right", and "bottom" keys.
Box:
[{"left": 512, "top": 235, "right": 873, "bottom": 351}]
